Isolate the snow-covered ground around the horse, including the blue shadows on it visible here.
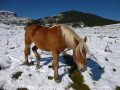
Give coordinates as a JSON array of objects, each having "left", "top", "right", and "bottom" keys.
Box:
[{"left": 0, "top": 24, "right": 120, "bottom": 90}]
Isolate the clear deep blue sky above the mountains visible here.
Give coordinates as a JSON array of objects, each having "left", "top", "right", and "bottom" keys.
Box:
[{"left": 0, "top": 0, "right": 120, "bottom": 21}]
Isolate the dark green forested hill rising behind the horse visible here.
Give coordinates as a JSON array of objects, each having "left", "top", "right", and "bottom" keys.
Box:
[{"left": 27, "top": 11, "right": 120, "bottom": 27}]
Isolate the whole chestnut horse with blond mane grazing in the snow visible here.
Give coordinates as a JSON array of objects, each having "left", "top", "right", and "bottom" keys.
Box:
[{"left": 25, "top": 24, "right": 88, "bottom": 82}]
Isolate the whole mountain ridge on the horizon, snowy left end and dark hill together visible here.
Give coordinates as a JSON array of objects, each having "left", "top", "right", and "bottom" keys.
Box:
[{"left": 0, "top": 10, "right": 120, "bottom": 27}]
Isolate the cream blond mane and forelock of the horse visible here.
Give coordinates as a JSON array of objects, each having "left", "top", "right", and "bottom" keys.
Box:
[{"left": 61, "top": 25, "right": 89, "bottom": 54}]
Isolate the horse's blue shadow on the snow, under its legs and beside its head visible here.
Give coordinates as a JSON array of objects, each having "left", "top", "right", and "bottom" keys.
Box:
[{"left": 32, "top": 55, "right": 105, "bottom": 81}]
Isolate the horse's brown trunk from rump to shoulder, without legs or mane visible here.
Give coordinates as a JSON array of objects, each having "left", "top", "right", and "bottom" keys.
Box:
[{"left": 26, "top": 24, "right": 64, "bottom": 51}]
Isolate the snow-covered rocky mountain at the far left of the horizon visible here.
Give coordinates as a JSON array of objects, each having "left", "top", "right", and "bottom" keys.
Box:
[{"left": 0, "top": 10, "right": 32, "bottom": 25}]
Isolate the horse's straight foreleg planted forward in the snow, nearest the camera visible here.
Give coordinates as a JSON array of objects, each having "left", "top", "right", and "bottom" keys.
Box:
[{"left": 52, "top": 51, "right": 61, "bottom": 83}]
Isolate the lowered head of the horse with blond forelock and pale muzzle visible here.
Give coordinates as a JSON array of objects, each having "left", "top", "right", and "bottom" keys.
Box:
[{"left": 73, "top": 37, "right": 88, "bottom": 72}]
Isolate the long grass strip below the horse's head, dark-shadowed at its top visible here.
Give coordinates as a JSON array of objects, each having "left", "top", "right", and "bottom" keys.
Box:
[{"left": 63, "top": 55, "right": 90, "bottom": 90}]
